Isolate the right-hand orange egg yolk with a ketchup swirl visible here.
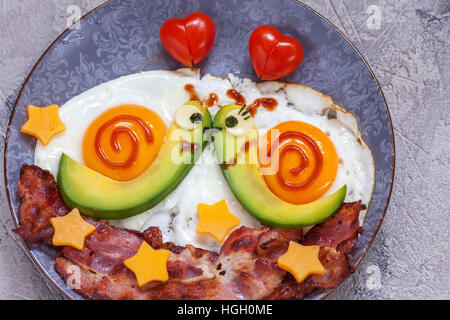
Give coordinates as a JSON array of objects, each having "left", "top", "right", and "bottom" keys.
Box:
[{"left": 260, "top": 121, "right": 338, "bottom": 204}]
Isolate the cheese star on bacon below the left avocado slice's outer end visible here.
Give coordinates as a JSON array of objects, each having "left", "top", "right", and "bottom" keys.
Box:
[{"left": 50, "top": 209, "right": 95, "bottom": 250}]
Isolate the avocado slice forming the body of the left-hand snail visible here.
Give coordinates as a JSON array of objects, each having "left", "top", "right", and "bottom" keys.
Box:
[{"left": 58, "top": 101, "right": 212, "bottom": 219}]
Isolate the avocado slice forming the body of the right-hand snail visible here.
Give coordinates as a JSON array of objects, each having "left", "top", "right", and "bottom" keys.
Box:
[{"left": 213, "top": 105, "right": 347, "bottom": 228}]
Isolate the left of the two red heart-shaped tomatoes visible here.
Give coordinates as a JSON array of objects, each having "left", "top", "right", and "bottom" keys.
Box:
[{"left": 159, "top": 12, "right": 216, "bottom": 67}]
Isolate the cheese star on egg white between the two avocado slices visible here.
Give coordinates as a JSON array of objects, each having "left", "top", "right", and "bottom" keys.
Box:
[{"left": 196, "top": 200, "right": 241, "bottom": 243}]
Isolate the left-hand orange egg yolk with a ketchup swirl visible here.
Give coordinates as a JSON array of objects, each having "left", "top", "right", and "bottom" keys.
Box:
[{"left": 83, "top": 105, "right": 167, "bottom": 181}]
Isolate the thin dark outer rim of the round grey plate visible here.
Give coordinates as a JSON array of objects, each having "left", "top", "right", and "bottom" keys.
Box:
[{"left": 3, "top": 0, "right": 396, "bottom": 300}]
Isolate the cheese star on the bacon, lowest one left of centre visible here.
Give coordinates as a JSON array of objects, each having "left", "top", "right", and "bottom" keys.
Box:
[{"left": 124, "top": 241, "right": 170, "bottom": 287}]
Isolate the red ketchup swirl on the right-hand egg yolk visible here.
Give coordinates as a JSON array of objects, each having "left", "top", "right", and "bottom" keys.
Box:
[{"left": 267, "top": 131, "right": 324, "bottom": 190}]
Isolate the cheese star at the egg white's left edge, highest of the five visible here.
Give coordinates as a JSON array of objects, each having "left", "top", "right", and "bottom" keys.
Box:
[{"left": 22, "top": 104, "right": 66, "bottom": 145}]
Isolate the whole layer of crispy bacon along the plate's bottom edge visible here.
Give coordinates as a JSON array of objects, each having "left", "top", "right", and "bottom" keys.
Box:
[{"left": 16, "top": 165, "right": 361, "bottom": 299}]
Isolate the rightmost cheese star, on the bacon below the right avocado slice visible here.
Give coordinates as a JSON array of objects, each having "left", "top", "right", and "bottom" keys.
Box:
[{"left": 278, "top": 241, "right": 325, "bottom": 282}]
